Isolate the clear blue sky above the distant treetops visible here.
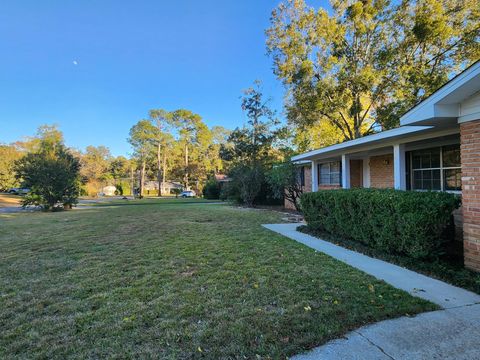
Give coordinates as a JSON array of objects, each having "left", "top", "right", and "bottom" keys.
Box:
[{"left": 0, "top": 0, "right": 330, "bottom": 155}]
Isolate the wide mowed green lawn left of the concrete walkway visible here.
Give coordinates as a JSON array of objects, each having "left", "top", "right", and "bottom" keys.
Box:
[{"left": 0, "top": 199, "right": 436, "bottom": 359}]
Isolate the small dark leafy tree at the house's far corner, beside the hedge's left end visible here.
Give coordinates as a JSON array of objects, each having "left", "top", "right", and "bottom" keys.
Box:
[{"left": 267, "top": 162, "right": 303, "bottom": 211}]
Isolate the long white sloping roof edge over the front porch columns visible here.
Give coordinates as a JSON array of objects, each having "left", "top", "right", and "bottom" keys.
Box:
[{"left": 292, "top": 125, "right": 434, "bottom": 162}]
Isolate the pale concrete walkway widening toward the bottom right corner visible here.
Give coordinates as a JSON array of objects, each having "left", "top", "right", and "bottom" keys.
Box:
[{"left": 264, "top": 224, "right": 480, "bottom": 360}]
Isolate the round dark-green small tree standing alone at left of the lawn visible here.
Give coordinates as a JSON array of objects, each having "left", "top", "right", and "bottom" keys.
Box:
[{"left": 15, "top": 141, "right": 80, "bottom": 210}]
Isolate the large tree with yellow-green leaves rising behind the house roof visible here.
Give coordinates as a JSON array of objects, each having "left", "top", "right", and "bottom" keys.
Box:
[{"left": 267, "top": 0, "right": 480, "bottom": 141}]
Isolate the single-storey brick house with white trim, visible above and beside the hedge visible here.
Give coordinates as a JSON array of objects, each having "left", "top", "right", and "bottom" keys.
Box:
[{"left": 286, "top": 61, "right": 480, "bottom": 271}]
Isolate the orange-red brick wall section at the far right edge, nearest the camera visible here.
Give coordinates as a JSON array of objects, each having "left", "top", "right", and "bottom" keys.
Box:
[{"left": 460, "top": 120, "right": 480, "bottom": 271}]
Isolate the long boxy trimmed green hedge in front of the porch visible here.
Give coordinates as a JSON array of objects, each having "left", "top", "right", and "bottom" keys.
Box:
[{"left": 300, "top": 189, "right": 460, "bottom": 258}]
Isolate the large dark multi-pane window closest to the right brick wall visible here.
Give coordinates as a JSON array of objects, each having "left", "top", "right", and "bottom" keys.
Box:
[{"left": 410, "top": 145, "right": 461, "bottom": 191}]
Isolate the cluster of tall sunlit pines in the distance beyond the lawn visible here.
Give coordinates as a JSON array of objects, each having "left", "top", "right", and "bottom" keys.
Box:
[{"left": 131, "top": 109, "right": 229, "bottom": 195}]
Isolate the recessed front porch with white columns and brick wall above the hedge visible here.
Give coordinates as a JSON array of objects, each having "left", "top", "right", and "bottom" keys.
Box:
[{"left": 310, "top": 127, "right": 461, "bottom": 192}]
